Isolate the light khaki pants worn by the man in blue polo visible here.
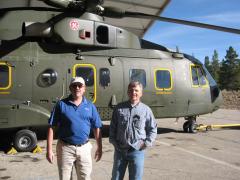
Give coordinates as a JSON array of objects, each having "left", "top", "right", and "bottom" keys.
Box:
[{"left": 57, "top": 140, "right": 92, "bottom": 180}]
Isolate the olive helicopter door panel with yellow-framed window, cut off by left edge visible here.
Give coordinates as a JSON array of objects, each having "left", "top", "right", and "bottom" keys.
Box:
[{"left": 0, "top": 60, "right": 32, "bottom": 128}]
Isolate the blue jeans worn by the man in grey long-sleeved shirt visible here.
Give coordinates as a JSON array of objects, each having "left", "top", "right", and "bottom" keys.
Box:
[{"left": 112, "top": 149, "right": 145, "bottom": 180}]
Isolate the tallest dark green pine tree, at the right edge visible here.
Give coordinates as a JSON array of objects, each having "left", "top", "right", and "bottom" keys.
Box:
[{"left": 219, "top": 46, "right": 240, "bottom": 90}]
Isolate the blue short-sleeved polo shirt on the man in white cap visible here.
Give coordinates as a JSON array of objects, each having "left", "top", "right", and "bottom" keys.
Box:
[{"left": 48, "top": 96, "right": 102, "bottom": 144}]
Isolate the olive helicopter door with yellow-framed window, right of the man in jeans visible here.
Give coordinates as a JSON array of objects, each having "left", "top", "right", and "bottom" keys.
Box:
[{"left": 149, "top": 60, "right": 176, "bottom": 118}]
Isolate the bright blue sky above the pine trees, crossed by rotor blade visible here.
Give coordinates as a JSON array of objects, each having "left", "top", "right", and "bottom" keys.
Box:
[{"left": 144, "top": 0, "right": 240, "bottom": 62}]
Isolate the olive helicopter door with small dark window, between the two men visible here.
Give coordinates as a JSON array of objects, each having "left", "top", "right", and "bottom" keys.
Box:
[{"left": 94, "top": 57, "right": 124, "bottom": 120}]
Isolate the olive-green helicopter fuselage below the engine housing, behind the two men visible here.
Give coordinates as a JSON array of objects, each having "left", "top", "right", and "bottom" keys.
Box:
[{"left": 0, "top": 42, "right": 221, "bottom": 128}]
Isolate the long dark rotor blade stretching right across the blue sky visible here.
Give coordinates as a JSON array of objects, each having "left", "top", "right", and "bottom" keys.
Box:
[{"left": 102, "top": 7, "right": 240, "bottom": 34}]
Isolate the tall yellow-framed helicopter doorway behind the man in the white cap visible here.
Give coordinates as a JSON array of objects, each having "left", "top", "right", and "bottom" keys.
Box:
[{"left": 73, "top": 64, "right": 97, "bottom": 103}]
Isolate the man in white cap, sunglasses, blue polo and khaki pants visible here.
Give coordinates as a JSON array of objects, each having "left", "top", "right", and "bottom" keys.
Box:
[{"left": 47, "top": 77, "right": 102, "bottom": 180}]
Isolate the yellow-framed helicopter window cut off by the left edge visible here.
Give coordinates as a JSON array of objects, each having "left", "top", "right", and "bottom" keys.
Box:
[{"left": 0, "top": 64, "right": 11, "bottom": 89}]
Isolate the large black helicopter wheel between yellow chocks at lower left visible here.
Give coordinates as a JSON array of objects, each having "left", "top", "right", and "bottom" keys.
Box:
[{"left": 13, "top": 129, "right": 37, "bottom": 152}]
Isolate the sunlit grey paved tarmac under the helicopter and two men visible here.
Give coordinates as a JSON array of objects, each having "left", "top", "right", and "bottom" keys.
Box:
[{"left": 0, "top": 109, "right": 240, "bottom": 180}]
